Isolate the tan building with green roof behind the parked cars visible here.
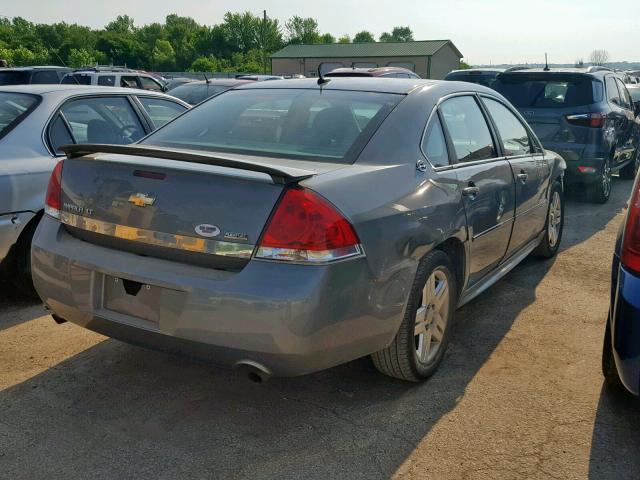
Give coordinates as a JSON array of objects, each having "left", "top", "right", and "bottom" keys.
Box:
[{"left": 271, "top": 40, "right": 463, "bottom": 79}]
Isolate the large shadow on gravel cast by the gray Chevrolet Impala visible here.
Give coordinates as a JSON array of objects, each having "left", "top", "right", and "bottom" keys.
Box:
[{"left": 0, "top": 177, "right": 626, "bottom": 480}]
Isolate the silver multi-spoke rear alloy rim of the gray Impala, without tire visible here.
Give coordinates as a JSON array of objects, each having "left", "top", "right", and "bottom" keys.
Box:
[{"left": 414, "top": 269, "right": 451, "bottom": 364}]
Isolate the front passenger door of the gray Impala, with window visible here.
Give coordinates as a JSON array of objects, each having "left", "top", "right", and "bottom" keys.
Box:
[{"left": 482, "top": 96, "right": 551, "bottom": 253}]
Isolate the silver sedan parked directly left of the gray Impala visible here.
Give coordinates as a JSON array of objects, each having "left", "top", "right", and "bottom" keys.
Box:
[{"left": 0, "top": 85, "right": 188, "bottom": 292}]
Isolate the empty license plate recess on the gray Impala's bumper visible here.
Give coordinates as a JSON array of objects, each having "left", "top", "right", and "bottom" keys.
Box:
[{"left": 102, "top": 275, "right": 164, "bottom": 325}]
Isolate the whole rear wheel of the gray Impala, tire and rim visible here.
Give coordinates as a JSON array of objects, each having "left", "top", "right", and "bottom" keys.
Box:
[{"left": 371, "top": 250, "right": 457, "bottom": 382}]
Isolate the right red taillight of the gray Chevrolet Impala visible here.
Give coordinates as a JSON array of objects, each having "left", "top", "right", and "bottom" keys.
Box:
[{"left": 256, "top": 188, "right": 362, "bottom": 263}]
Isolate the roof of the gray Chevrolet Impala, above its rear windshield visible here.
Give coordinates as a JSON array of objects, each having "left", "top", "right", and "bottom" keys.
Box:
[{"left": 238, "top": 77, "right": 444, "bottom": 94}]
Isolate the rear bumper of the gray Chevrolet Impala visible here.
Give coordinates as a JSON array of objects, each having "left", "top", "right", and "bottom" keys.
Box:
[{"left": 32, "top": 216, "right": 404, "bottom": 376}]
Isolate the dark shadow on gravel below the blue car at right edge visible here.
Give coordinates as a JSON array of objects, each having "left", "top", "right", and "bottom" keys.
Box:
[{"left": 589, "top": 386, "right": 640, "bottom": 480}]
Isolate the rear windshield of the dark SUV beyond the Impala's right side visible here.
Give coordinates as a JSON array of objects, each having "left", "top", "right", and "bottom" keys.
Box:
[{"left": 493, "top": 73, "right": 602, "bottom": 108}]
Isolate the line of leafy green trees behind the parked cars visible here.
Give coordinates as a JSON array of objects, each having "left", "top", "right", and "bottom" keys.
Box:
[{"left": 0, "top": 12, "right": 413, "bottom": 72}]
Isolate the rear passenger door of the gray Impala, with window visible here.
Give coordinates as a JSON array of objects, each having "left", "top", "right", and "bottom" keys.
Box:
[{"left": 439, "top": 94, "right": 515, "bottom": 285}]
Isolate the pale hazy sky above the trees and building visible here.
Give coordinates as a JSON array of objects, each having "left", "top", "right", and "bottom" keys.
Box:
[{"left": 0, "top": 0, "right": 640, "bottom": 65}]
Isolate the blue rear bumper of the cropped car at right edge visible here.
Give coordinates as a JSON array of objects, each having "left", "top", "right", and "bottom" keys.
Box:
[{"left": 610, "top": 266, "right": 640, "bottom": 395}]
